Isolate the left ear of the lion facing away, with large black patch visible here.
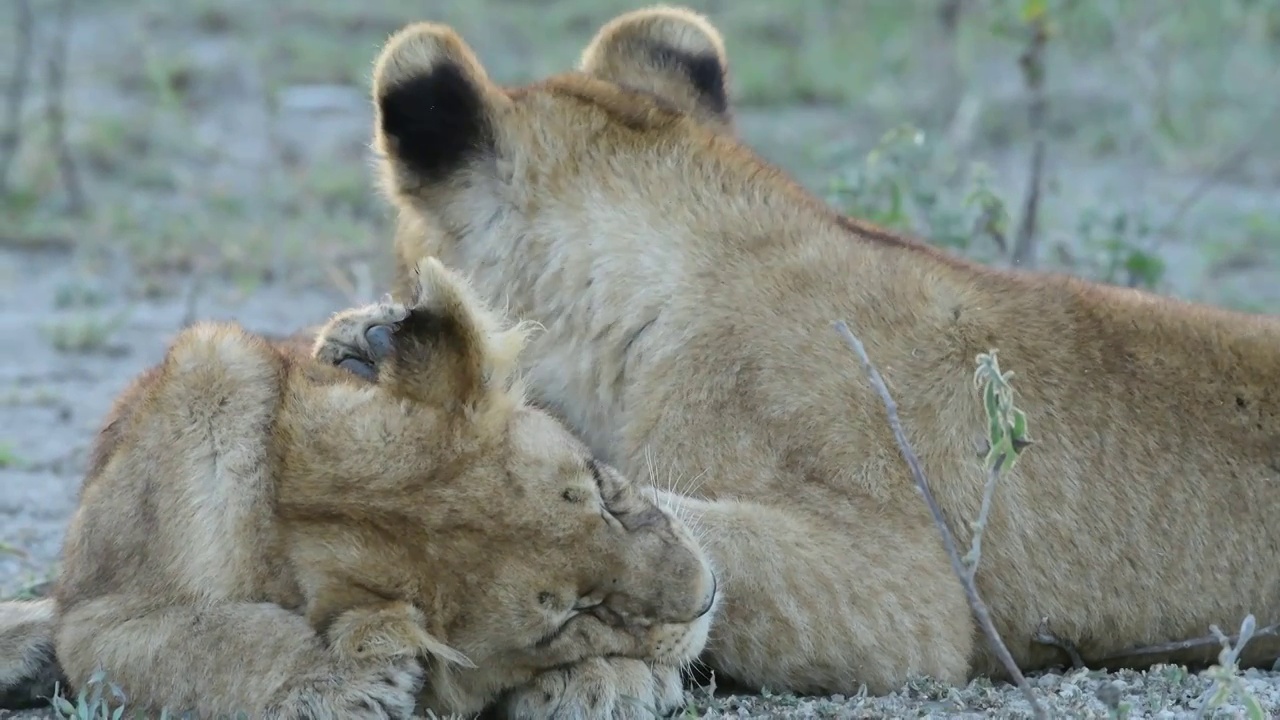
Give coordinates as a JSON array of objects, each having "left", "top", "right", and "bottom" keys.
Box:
[{"left": 372, "top": 23, "right": 508, "bottom": 191}]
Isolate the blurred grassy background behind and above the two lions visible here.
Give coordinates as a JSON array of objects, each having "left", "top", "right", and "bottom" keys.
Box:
[{"left": 0, "top": 0, "right": 1280, "bottom": 604}]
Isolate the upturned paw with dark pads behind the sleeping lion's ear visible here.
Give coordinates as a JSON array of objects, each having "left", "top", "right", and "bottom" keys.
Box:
[{"left": 312, "top": 302, "right": 408, "bottom": 380}]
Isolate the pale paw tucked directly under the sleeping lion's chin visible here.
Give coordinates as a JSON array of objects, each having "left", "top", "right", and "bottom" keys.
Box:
[{"left": 503, "top": 657, "right": 685, "bottom": 720}]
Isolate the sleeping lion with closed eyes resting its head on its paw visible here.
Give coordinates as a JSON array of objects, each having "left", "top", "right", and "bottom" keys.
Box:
[{"left": 0, "top": 254, "right": 716, "bottom": 719}]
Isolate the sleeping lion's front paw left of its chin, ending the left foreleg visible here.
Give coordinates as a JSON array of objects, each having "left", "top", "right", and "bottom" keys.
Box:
[{"left": 264, "top": 656, "right": 425, "bottom": 720}]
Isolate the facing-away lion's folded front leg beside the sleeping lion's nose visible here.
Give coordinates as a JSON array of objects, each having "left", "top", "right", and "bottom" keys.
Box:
[{"left": 654, "top": 491, "right": 978, "bottom": 694}]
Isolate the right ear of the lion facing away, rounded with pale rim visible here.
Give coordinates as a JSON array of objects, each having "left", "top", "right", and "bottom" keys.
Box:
[{"left": 579, "top": 5, "right": 732, "bottom": 129}]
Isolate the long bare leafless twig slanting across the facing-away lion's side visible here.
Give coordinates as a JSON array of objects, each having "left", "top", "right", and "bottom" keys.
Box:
[{"left": 836, "top": 320, "right": 1047, "bottom": 717}]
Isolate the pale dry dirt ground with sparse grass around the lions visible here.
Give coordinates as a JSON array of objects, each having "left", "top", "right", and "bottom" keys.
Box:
[{"left": 0, "top": 0, "right": 1280, "bottom": 717}]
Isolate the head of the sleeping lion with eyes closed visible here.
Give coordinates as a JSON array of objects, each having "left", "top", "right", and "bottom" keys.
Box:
[{"left": 296, "top": 258, "right": 716, "bottom": 711}]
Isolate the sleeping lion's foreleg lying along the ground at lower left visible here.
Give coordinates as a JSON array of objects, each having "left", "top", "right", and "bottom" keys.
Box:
[{"left": 55, "top": 596, "right": 424, "bottom": 720}]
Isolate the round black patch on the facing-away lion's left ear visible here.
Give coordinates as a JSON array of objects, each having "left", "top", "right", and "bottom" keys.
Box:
[{"left": 378, "top": 64, "right": 493, "bottom": 182}]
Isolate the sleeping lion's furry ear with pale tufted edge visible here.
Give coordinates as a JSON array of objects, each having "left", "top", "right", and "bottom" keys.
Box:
[{"left": 378, "top": 258, "right": 527, "bottom": 415}]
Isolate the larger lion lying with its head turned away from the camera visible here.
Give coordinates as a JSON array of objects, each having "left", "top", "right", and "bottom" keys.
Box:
[{"left": 372, "top": 9, "right": 1280, "bottom": 693}]
